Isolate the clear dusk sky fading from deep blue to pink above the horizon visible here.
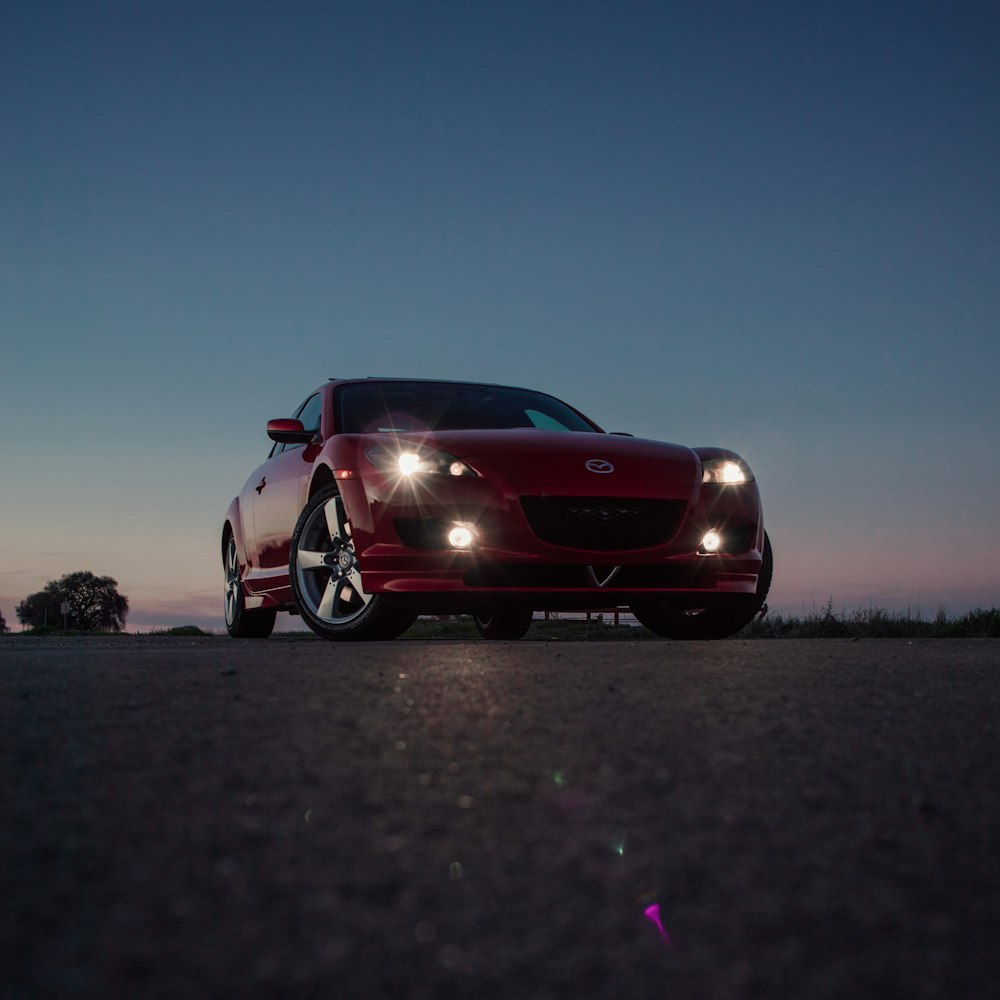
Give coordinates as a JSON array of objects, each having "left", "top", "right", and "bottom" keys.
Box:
[{"left": 0, "top": 0, "right": 1000, "bottom": 628}]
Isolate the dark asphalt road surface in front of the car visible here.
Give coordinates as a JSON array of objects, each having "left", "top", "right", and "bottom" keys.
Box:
[{"left": 0, "top": 637, "right": 1000, "bottom": 1000}]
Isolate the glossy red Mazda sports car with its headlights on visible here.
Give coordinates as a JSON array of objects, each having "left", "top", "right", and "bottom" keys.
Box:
[{"left": 222, "top": 378, "right": 772, "bottom": 639}]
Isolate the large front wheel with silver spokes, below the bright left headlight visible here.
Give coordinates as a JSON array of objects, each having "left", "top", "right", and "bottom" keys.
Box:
[{"left": 288, "top": 484, "right": 417, "bottom": 640}]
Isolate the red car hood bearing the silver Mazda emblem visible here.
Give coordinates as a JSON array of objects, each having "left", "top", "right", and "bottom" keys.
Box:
[{"left": 396, "top": 428, "right": 701, "bottom": 500}]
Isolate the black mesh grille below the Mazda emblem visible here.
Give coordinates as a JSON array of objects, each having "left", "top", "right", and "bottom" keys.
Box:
[{"left": 521, "top": 497, "right": 687, "bottom": 552}]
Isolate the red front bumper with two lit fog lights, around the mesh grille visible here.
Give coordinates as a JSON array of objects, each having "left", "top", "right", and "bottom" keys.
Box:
[{"left": 341, "top": 479, "right": 764, "bottom": 612}]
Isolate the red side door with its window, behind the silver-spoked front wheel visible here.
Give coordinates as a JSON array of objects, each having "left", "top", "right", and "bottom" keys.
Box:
[{"left": 250, "top": 393, "right": 323, "bottom": 590}]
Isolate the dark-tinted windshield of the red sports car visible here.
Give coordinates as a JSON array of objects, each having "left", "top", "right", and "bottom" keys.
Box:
[{"left": 336, "top": 382, "right": 600, "bottom": 434}]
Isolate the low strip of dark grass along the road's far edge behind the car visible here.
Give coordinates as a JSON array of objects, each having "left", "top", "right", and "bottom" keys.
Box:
[{"left": 3, "top": 601, "right": 1000, "bottom": 642}]
